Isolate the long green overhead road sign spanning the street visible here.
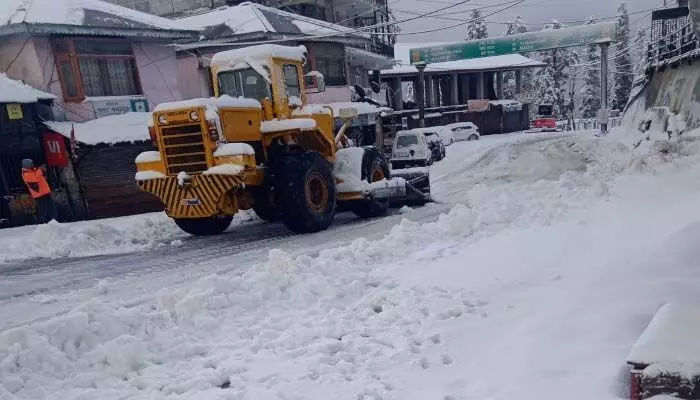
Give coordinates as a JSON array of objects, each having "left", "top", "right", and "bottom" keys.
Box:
[{"left": 411, "top": 22, "right": 617, "bottom": 64}]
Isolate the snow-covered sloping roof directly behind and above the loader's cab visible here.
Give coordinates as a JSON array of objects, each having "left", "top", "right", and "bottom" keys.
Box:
[{"left": 176, "top": 2, "right": 353, "bottom": 37}]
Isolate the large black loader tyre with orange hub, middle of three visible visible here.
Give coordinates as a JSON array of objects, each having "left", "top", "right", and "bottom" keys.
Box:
[{"left": 275, "top": 151, "right": 337, "bottom": 233}]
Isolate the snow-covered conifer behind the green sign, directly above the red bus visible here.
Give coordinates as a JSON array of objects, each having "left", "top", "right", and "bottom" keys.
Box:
[{"left": 535, "top": 20, "right": 578, "bottom": 117}]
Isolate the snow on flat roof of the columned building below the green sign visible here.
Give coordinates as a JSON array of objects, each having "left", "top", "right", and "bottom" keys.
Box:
[{"left": 381, "top": 54, "right": 544, "bottom": 75}]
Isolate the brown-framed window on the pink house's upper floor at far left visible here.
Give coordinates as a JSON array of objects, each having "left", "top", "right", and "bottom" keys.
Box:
[{"left": 52, "top": 39, "right": 142, "bottom": 101}]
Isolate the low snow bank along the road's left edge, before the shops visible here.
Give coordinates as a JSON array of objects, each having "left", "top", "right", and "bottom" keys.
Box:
[{"left": 0, "top": 213, "right": 186, "bottom": 263}]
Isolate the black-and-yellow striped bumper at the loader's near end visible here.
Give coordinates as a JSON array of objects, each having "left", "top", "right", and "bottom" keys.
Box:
[{"left": 138, "top": 173, "right": 244, "bottom": 218}]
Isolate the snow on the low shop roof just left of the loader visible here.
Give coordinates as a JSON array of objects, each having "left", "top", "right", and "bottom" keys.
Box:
[{"left": 44, "top": 112, "right": 153, "bottom": 145}]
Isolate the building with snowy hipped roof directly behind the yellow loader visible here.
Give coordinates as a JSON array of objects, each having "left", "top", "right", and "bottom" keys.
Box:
[{"left": 176, "top": 2, "right": 394, "bottom": 103}]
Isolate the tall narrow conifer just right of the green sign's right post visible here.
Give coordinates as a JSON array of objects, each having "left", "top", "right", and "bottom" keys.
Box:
[{"left": 612, "top": 0, "right": 633, "bottom": 110}]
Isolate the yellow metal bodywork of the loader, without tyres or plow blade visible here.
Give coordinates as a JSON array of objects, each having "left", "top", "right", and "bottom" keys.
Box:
[{"left": 137, "top": 49, "right": 336, "bottom": 222}]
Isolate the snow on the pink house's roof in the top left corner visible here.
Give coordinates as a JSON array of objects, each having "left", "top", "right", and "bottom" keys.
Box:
[{"left": 0, "top": 0, "right": 194, "bottom": 31}]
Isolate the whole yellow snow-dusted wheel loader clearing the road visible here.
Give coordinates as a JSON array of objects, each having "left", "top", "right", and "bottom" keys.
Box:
[{"left": 131, "top": 45, "right": 429, "bottom": 236}]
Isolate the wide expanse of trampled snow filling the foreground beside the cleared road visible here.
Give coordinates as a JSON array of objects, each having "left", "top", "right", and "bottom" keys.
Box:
[{"left": 0, "top": 133, "right": 700, "bottom": 400}]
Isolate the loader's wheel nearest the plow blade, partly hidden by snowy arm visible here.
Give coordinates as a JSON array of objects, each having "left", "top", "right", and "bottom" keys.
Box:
[{"left": 351, "top": 146, "right": 391, "bottom": 218}]
